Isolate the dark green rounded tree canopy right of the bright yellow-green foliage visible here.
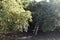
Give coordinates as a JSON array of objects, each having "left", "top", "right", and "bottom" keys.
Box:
[{"left": 27, "top": 1, "right": 58, "bottom": 32}]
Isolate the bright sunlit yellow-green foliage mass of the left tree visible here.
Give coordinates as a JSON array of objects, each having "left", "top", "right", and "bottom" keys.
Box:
[{"left": 0, "top": 0, "right": 32, "bottom": 32}]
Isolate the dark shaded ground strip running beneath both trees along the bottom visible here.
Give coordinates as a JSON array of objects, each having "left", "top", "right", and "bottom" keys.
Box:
[{"left": 0, "top": 31, "right": 60, "bottom": 40}]
